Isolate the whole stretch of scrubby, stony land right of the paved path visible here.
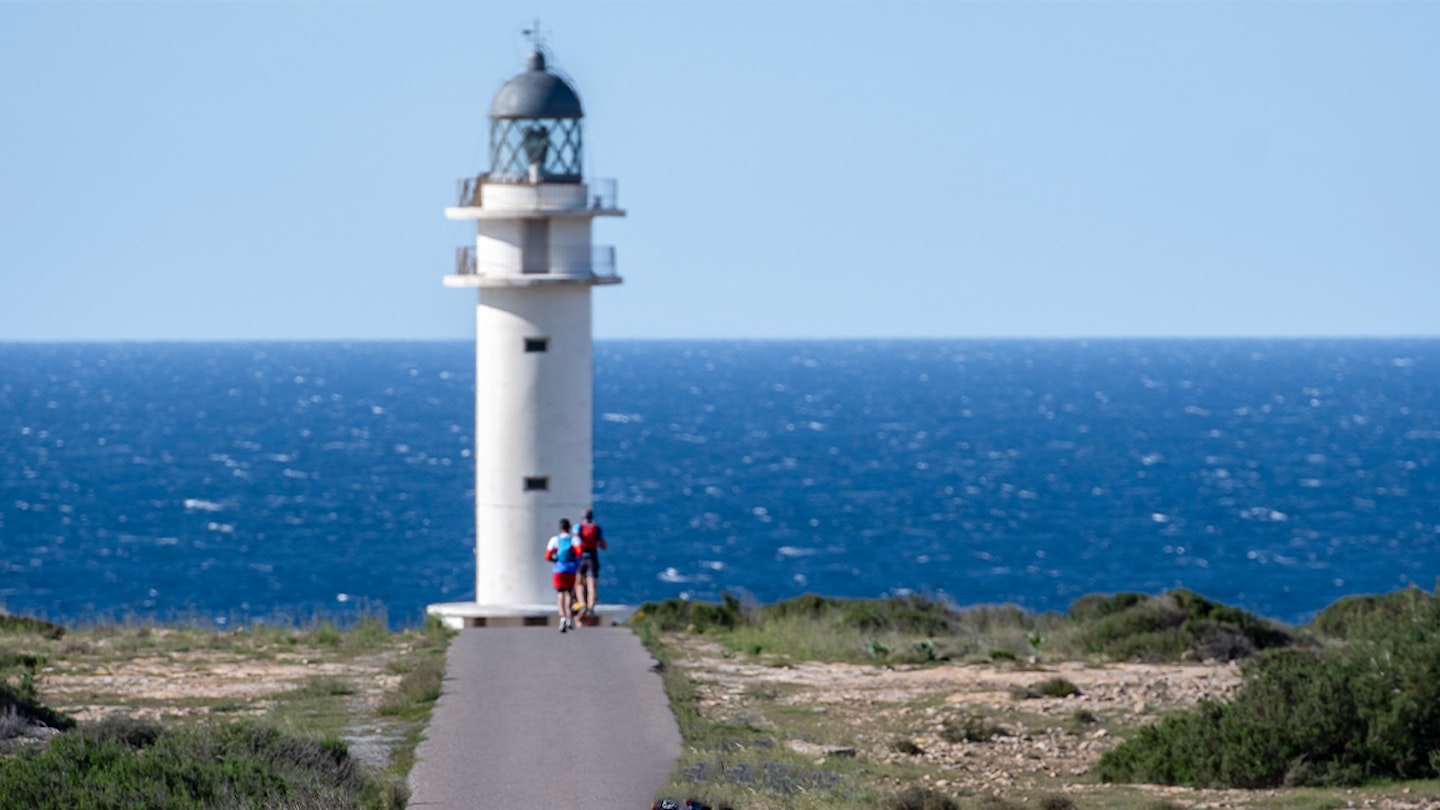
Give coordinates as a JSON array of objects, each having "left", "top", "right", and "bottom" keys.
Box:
[{"left": 632, "top": 588, "right": 1440, "bottom": 810}]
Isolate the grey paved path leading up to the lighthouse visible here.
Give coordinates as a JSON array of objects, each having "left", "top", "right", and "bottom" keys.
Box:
[{"left": 409, "top": 627, "right": 680, "bottom": 810}]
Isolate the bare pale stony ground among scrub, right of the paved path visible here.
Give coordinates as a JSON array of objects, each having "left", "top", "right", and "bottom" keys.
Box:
[{"left": 668, "top": 637, "right": 1440, "bottom": 810}]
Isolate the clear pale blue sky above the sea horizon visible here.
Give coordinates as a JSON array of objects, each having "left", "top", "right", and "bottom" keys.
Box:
[{"left": 0, "top": 0, "right": 1440, "bottom": 340}]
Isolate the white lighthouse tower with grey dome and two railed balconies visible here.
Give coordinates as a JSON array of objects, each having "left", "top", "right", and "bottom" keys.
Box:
[{"left": 429, "top": 40, "right": 625, "bottom": 627}]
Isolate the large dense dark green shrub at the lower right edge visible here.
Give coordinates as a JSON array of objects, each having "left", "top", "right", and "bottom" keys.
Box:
[{"left": 1096, "top": 600, "right": 1440, "bottom": 788}]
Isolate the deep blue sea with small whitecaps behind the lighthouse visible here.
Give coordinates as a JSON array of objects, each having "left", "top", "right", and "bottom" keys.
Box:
[{"left": 0, "top": 339, "right": 1440, "bottom": 626}]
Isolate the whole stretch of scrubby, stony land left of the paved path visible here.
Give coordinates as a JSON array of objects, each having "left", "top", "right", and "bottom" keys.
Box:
[{"left": 0, "top": 613, "right": 451, "bottom": 810}]
